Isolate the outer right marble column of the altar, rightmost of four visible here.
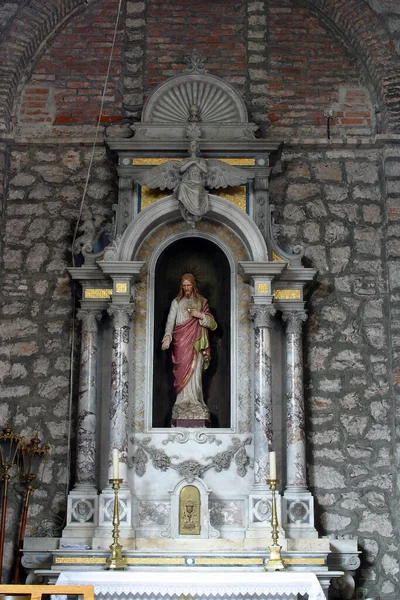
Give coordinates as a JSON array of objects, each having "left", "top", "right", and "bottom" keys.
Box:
[{"left": 282, "top": 311, "right": 307, "bottom": 491}]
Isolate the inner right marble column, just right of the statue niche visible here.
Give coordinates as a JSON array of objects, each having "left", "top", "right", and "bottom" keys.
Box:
[{"left": 250, "top": 304, "right": 276, "bottom": 486}]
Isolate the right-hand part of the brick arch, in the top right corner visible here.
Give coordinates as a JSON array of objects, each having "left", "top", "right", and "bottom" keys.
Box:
[{"left": 295, "top": 0, "right": 400, "bottom": 133}]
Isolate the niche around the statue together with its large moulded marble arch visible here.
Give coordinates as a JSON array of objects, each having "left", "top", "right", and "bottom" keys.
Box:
[{"left": 99, "top": 195, "right": 285, "bottom": 432}]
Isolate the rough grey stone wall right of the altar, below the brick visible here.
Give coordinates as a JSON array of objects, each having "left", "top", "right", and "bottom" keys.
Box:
[{"left": 271, "top": 146, "right": 398, "bottom": 597}]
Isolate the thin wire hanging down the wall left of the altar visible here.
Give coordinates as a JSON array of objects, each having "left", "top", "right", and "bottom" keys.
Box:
[{"left": 66, "top": 0, "right": 122, "bottom": 506}]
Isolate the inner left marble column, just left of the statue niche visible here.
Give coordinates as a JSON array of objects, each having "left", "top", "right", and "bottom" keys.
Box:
[{"left": 107, "top": 303, "right": 134, "bottom": 481}]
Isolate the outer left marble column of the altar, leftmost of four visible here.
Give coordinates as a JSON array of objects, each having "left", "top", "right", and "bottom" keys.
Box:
[{"left": 75, "top": 309, "right": 101, "bottom": 488}]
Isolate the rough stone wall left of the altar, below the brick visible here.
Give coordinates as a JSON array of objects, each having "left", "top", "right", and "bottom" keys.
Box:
[{"left": 0, "top": 144, "right": 116, "bottom": 572}]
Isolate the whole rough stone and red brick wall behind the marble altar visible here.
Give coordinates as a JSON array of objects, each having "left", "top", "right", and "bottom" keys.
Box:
[{"left": 0, "top": 0, "right": 400, "bottom": 600}]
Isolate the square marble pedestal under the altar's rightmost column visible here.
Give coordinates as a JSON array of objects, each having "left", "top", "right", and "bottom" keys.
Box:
[{"left": 282, "top": 487, "right": 318, "bottom": 539}]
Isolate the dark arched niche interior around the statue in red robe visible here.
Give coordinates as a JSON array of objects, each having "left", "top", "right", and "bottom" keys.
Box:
[{"left": 152, "top": 236, "right": 231, "bottom": 428}]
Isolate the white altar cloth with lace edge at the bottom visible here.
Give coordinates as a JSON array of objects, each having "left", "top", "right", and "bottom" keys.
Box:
[{"left": 57, "top": 568, "right": 325, "bottom": 600}]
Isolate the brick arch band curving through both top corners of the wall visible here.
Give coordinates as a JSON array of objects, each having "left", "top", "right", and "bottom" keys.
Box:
[{"left": 0, "top": 0, "right": 400, "bottom": 133}]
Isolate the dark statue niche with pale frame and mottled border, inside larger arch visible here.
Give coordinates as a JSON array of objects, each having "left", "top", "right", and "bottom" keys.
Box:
[{"left": 133, "top": 219, "right": 245, "bottom": 432}]
